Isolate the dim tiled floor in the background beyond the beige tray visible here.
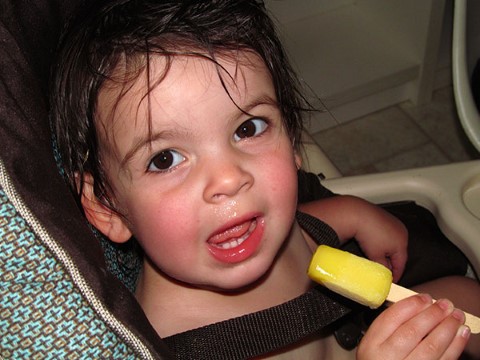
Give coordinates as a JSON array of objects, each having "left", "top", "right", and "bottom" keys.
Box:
[{"left": 313, "top": 86, "right": 480, "bottom": 175}]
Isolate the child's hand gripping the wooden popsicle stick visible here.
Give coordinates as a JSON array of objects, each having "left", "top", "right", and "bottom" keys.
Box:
[{"left": 357, "top": 294, "right": 470, "bottom": 360}]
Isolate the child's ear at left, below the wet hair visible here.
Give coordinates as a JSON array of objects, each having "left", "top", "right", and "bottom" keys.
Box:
[{"left": 81, "top": 174, "right": 132, "bottom": 243}]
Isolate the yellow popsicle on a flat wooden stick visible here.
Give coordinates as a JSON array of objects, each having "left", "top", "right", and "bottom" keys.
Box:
[{"left": 308, "top": 245, "right": 480, "bottom": 334}]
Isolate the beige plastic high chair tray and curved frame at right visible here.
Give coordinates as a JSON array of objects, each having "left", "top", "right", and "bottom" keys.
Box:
[{"left": 304, "top": 0, "right": 480, "bottom": 275}]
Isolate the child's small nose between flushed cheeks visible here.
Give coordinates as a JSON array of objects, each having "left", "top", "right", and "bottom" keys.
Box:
[{"left": 204, "top": 157, "right": 254, "bottom": 203}]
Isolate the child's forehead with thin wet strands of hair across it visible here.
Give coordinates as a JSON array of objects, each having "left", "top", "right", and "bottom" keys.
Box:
[{"left": 95, "top": 51, "right": 275, "bottom": 145}]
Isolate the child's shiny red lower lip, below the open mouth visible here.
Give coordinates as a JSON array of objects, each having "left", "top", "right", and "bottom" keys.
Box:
[{"left": 208, "top": 218, "right": 265, "bottom": 264}]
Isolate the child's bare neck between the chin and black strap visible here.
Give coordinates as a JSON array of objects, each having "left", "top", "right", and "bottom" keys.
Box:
[{"left": 136, "top": 222, "right": 312, "bottom": 337}]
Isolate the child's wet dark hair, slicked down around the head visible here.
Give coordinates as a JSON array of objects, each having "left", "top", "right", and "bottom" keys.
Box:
[{"left": 51, "top": 0, "right": 310, "bottom": 206}]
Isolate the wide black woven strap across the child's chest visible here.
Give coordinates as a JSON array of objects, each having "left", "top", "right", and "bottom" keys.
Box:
[{"left": 164, "top": 287, "right": 349, "bottom": 360}]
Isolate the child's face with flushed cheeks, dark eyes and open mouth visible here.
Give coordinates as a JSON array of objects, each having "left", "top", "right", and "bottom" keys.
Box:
[{"left": 97, "top": 53, "right": 298, "bottom": 289}]
